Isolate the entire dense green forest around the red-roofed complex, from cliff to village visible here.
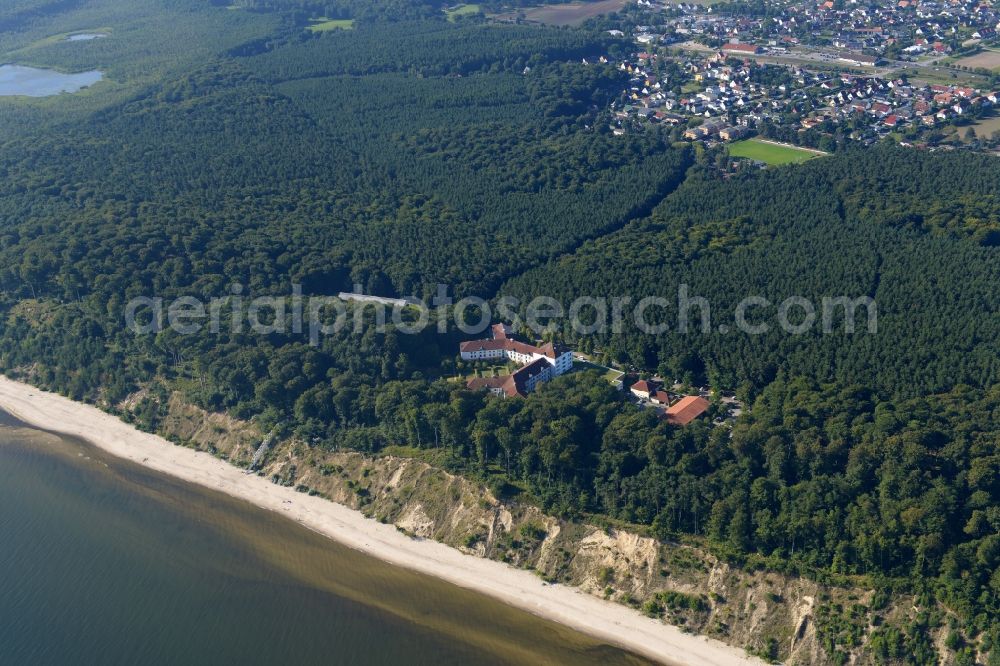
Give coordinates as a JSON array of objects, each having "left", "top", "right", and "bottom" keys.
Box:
[{"left": 0, "top": 0, "right": 1000, "bottom": 664}]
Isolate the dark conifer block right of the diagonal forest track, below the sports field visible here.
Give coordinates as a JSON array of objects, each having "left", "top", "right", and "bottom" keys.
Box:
[{"left": 503, "top": 149, "right": 1000, "bottom": 397}]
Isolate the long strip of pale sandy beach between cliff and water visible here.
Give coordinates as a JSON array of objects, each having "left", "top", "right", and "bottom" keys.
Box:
[{"left": 0, "top": 376, "right": 762, "bottom": 666}]
